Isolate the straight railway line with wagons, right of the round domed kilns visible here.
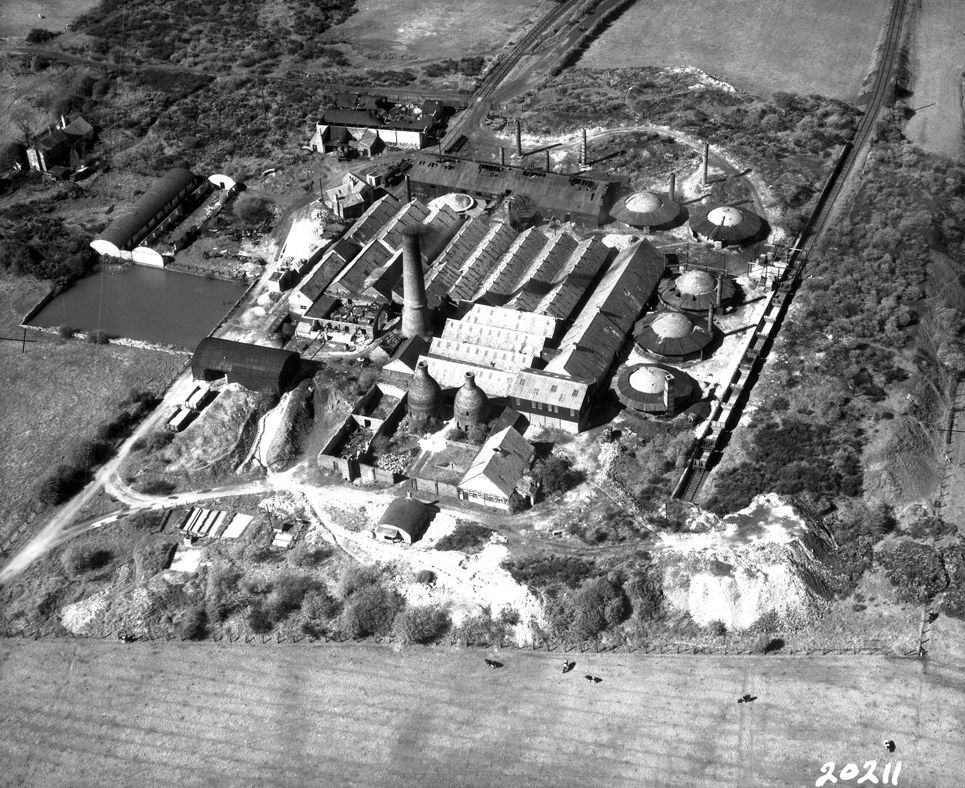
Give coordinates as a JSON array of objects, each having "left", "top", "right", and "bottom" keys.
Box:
[{"left": 673, "top": 0, "right": 908, "bottom": 502}]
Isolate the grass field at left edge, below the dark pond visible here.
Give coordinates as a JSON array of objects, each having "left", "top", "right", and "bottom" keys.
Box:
[{"left": 0, "top": 274, "right": 186, "bottom": 535}]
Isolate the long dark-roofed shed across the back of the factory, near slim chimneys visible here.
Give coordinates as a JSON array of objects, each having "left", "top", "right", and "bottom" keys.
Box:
[{"left": 409, "top": 153, "right": 616, "bottom": 226}]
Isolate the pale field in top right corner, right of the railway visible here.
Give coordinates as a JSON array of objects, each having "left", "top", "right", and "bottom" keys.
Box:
[{"left": 905, "top": 0, "right": 965, "bottom": 156}]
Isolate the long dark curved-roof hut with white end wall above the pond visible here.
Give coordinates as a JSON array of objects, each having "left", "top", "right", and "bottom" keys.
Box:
[{"left": 90, "top": 167, "right": 206, "bottom": 257}]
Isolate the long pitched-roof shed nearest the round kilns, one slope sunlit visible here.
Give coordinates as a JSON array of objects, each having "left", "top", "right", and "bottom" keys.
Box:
[{"left": 546, "top": 241, "right": 666, "bottom": 383}]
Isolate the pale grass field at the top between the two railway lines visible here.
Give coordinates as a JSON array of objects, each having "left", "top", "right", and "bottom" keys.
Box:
[{"left": 580, "top": 0, "right": 892, "bottom": 99}]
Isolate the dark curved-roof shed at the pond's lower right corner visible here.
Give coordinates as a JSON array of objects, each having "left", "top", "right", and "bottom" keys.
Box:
[{"left": 191, "top": 337, "right": 301, "bottom": 394}]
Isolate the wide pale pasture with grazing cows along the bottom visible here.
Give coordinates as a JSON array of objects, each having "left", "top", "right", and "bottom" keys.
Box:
[{"left": 0, "top": 639, "right": 965, "bottom": 788}]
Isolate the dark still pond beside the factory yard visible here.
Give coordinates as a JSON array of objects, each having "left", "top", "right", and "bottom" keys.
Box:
[{"left": 30, "top": 265, "right": 246, "bottom": 350}]
